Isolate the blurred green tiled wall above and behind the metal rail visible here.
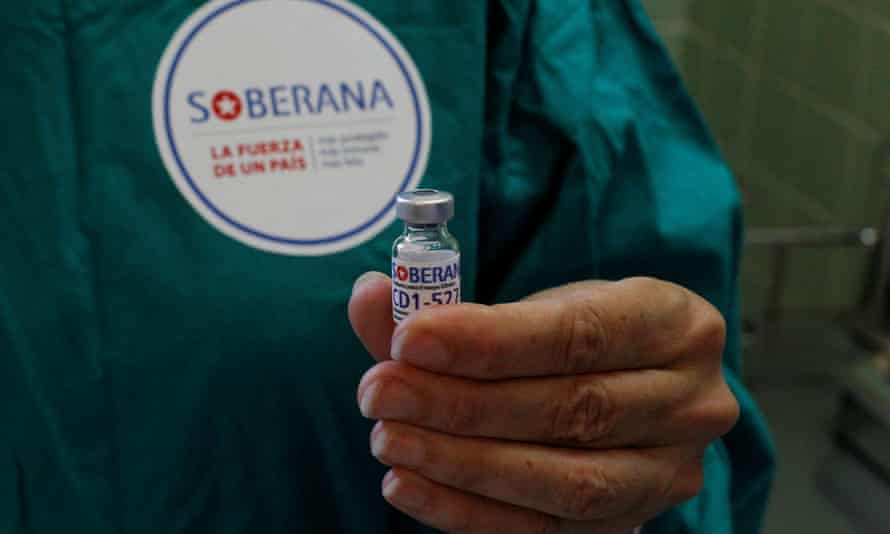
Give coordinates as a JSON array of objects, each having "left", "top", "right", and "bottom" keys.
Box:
[{"left": 645, "top": 0, "right": 890, "bottom": 311}]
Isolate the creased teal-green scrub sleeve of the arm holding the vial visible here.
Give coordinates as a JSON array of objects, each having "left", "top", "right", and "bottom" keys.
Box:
[{"left": 477, "top": 0, "right": 773, "bottom": 534}]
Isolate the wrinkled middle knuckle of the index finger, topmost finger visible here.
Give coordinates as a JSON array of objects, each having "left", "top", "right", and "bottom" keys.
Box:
[{"left": 559, "top": 298, "right": 609, "bottom": 374}]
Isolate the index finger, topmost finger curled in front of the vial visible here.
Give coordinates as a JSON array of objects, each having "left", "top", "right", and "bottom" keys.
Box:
[{"left": 392, "top": 279, "right": 698, "bottom": 380}]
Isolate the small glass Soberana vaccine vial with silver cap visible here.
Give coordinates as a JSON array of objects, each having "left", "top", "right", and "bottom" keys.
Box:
[{"left": 392, "top": 189, "right": 460, "bottom": 323}]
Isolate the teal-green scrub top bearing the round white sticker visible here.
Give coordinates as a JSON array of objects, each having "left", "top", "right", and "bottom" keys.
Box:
[{"left": 0, "top": 0, "right": 772, "bottom": 534}]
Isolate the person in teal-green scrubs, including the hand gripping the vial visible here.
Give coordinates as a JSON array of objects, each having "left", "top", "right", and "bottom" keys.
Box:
[{"left": 0, "top": 0, "right": 773, "bottom": 534}]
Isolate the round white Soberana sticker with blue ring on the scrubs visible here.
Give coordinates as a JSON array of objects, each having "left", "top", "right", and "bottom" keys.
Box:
[{"left": 152, "top": 0, "right": 432, "bottom": 256}]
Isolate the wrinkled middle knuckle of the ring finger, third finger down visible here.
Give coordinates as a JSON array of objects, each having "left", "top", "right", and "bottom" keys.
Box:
[{"left": 556, "top": 465, "right": 623, "bottom": 521}]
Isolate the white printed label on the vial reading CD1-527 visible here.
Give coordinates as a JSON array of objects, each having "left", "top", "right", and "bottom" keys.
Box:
[{"left": 392, "top": 253, "right": 460, "bottom": 323}]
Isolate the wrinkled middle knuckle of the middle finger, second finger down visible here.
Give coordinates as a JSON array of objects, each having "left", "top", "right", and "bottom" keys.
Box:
[{"left": 551, "top": 377, "right": 617, "bottom": 447}]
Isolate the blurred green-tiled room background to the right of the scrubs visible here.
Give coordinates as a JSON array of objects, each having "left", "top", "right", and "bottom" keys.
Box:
[{"left": 644, "top": 0, "right": 890, "bottom": 534}]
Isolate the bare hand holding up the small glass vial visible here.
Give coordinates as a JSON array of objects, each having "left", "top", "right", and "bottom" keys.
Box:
[{"left": 349, "top": 274, "right": 739, "bottom": 534}]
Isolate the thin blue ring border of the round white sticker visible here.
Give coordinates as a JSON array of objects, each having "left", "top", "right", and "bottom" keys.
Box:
[{"left": 164, "top": 0, "right": 423, "bottom": 246}]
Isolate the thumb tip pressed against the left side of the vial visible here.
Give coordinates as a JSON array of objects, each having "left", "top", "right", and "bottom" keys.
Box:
[{"left": 349, "top": 272, "right": 395, "bottom": 362}]
